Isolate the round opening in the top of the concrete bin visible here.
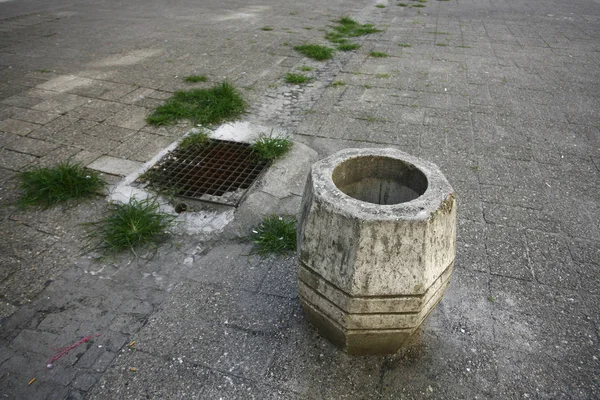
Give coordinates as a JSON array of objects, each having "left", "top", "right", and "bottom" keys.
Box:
[{"left": 332, "top": 156, "right": 427, "bottom": 205}]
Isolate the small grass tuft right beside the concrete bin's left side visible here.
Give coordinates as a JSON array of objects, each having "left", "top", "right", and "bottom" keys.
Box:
[{"left": 251, "top": 215, "right": 296, "bottom": 256}]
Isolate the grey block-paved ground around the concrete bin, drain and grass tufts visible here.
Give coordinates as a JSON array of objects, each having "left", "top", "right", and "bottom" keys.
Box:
[{"left": 0, "top": 0, "right": 600, "bottom": 399}]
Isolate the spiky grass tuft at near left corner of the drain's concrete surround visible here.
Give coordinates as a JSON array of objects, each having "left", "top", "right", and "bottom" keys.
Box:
[{"left": 85, "top": 198, "right": 175, "bottom": 255}]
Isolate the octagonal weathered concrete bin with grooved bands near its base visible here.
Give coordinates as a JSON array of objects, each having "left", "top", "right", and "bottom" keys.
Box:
[{"left": 298, "top": 149, "right": 456, "bottom": 354}]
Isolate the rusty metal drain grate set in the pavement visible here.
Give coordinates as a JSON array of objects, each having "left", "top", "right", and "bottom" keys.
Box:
[{"left": 138, "top": 139, "right": 268, "bottom": 206}]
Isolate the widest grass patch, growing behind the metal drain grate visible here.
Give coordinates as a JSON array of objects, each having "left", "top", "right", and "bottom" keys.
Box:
[{"left": 146, "top": 81, "right": 246, "bottom": 126}]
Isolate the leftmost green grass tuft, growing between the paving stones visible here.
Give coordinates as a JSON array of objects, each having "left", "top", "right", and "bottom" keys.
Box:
[{"left": 17, "top": 161, "right": 106, "bottom": 208}]
